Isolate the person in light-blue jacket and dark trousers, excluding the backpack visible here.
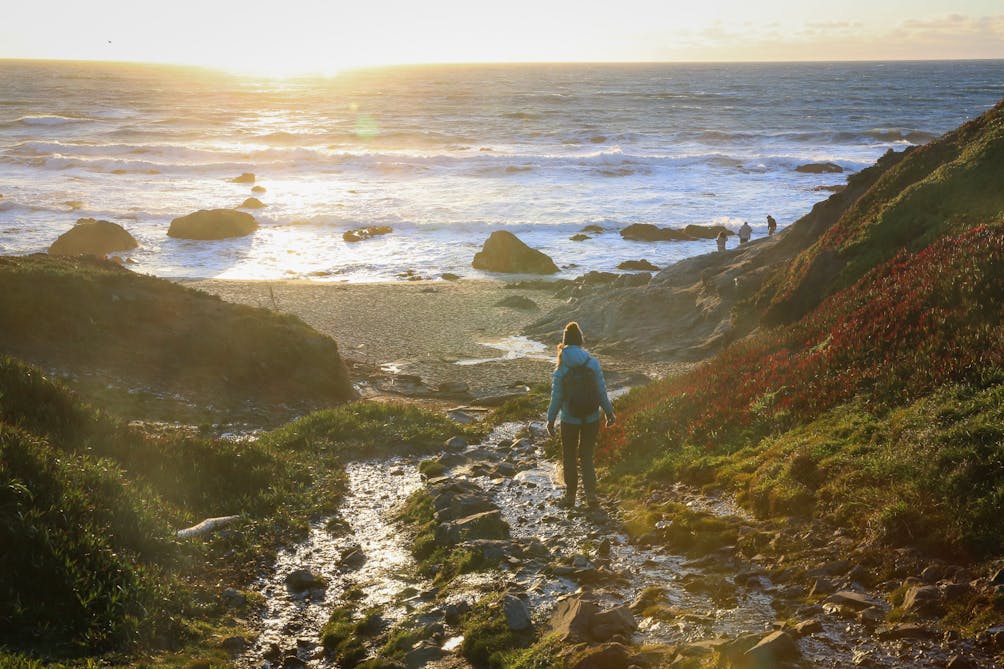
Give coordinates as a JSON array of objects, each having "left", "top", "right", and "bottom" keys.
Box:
[{"left": 547, "top": 322, "right": 616, "bottom": 508}]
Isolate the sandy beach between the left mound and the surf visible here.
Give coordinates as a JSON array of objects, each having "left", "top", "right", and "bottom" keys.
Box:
[{"left": 183, "top": 279, "right": 606, "bottom": 397}]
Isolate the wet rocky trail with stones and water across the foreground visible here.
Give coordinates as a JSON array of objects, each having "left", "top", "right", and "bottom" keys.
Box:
[{"left": 239, "top": 423, "right": 991, "bottom": 669}]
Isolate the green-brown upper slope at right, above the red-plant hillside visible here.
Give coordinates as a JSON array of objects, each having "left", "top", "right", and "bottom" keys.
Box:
[{"left": 757, "top": 100, "right": 1004, "bottom": 323}]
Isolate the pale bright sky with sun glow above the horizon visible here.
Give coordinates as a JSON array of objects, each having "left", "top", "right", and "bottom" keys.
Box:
[{"left": 0, "top": 0, "right": 1004, "bottom": 74}]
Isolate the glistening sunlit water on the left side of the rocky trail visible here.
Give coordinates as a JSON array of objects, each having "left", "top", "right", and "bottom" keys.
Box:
[{"left": 243, "top": 459, "right": 429, "bottom": 667}]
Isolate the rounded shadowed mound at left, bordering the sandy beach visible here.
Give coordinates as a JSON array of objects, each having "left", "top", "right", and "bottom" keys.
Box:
[{"left": 0, "top": 255, "right": 352, "bottom": 418}]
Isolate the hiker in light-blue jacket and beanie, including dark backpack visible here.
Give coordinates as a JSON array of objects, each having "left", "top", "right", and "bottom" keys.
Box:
[{"left": 547, "top": 322, "right": 616, "bottom": 508}]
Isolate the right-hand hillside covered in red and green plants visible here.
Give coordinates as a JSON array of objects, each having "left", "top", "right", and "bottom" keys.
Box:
[{"left": 600, "top": 100, "right": 1004, "bottom": 559}]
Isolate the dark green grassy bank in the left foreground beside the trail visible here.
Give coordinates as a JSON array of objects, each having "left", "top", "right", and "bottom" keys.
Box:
[{"left": 0, "top": 358, "right": 476, "bottom": 665}]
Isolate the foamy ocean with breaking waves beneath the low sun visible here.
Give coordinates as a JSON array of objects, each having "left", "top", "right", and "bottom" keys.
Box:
[{"left": 0, "top": 60, "right": 1004, "bottom": 282}]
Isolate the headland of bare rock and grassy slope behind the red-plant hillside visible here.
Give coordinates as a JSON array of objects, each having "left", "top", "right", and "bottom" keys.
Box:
[{"left": 528, "top": 96, "right": 1004, "bottom": 362}]
